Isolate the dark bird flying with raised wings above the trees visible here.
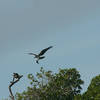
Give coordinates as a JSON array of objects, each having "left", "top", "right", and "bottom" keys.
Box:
[{"left": 28, "top": 46, "right": 53, "bottom": 64}]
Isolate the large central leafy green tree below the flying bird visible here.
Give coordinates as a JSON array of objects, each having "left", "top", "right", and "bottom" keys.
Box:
[{"left": 16, "top": 67, "right": 84, "bottom": 100}]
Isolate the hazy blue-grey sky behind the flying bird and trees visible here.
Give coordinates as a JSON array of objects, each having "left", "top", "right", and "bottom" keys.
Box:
[{"left": 0, "top": 0, "right": 100, "bottom": 100}]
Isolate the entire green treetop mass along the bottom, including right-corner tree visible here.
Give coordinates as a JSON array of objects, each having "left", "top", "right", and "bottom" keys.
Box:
[{"left": 5, "top": 67, "right": 100, "bottom": 100}]
